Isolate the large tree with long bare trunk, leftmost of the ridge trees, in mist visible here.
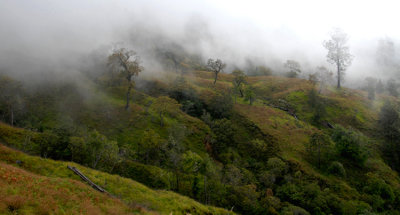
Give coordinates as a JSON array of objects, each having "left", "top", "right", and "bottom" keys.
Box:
[{"left": 108, "top": 48, "right": 143, "bottom": 110}]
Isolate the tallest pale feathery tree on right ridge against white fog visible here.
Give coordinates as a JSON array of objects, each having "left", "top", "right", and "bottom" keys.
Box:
[{"left": 323, "top": 29, "right": 353, "bottom": 88}]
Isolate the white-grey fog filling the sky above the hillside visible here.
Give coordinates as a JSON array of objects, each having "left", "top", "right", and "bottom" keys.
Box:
[{"left": 0, "top": 0, "right": 400, "bottom": 85}]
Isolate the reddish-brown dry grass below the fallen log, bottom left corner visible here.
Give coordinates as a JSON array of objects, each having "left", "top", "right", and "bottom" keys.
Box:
[{"left": 0, "top": 163, "right": 141, "bottom": 215}]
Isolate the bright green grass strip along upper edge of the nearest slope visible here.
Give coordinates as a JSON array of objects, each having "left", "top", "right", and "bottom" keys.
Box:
[{"left": 0, "top": 145, "right": 231, "bottom": 214}]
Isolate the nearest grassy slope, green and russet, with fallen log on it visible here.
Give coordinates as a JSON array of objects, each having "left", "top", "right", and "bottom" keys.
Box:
[{"left": 0, "top": 145, "right": 228, "bottom": 214}]
